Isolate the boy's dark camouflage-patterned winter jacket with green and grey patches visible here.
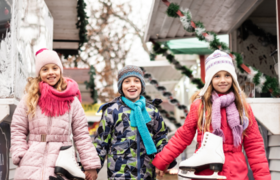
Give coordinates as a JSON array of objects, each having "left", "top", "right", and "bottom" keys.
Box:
[{"left": 94, "top": 97, "right": 176, "bottom": 180}]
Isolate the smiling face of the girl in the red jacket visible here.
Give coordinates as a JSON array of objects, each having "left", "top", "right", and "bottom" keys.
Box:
[{"left": 212, "top": 71, "right": 232, "bottom": 94}]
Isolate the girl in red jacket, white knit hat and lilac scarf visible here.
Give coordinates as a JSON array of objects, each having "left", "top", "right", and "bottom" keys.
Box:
[{"left": 152, "top": 50, "right": 271, "bottom": 180}]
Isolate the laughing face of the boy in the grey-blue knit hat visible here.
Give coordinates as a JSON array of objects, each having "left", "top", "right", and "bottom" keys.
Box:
[{"left": 122, "top": 77, "right": 142, "bottom": 102}]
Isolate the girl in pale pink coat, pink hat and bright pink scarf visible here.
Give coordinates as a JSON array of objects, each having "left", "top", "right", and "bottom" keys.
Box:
[{"left": 11, "top": 49, "right": 101, "bottom": 180}]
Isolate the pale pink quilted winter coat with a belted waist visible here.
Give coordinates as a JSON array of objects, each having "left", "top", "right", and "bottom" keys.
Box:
[{"left": 11, "top": 97, "right": 101, "bottom": 180}]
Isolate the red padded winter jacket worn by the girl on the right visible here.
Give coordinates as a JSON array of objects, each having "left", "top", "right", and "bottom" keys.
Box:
[{"left": 152, "top": 100, "right": 271, "bottom": 180}]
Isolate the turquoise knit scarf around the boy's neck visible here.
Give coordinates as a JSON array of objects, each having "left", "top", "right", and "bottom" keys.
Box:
[{"left": 122, "top": 96, "right": 157, "bottom": 155}]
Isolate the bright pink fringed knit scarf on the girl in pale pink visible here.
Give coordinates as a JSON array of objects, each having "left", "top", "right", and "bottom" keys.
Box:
[{"left": 38, "top": 78, "right": 81, "bottom": 117}]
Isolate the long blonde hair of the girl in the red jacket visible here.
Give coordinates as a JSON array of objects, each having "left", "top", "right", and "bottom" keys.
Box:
[{"left": 191, "top": 81, "right": 248, "bottom": 132}]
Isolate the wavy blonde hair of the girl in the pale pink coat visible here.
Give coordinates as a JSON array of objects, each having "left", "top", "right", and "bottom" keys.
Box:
[{"left": 24, "top": 74, "right": 67, "bottom": 117}]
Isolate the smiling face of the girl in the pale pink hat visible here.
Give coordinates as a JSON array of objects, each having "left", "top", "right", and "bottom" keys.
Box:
[{"left": 40, "top": 64, "right": 60, "bottom": 86}]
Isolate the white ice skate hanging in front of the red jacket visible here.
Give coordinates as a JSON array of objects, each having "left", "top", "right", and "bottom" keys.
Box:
[{"left": 178, "top": 132, "right": 226, "bottom": 179}]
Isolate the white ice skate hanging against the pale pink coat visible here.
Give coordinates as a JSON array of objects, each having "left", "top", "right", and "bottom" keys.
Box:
[{"left": 54, "top": 145, "right": 85, "bottom": 180}]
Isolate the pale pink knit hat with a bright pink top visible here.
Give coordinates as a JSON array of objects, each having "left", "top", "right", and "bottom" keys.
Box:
[{"left": 36, "top": 48, "right": 63, "bottom": 76}]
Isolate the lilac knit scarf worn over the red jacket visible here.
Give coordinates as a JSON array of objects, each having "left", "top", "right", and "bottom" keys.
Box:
[{"left": 211, "top": 91, "right": 243, "bottom": 147}]
